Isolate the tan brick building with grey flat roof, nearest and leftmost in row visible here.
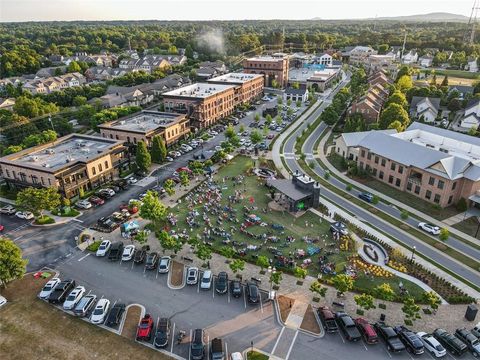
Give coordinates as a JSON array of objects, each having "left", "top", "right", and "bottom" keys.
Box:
[{"left": 0, "top": 134, "right": 129, "bottom": 198}]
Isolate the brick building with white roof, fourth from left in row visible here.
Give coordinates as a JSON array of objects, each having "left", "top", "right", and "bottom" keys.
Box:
[{"left": 208, "top": 73, "right": 263, "bottom": 106}]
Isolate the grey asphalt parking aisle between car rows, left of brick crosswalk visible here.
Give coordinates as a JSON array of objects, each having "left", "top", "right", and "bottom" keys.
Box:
[{"left": 57, "top": 249, "right": 281, "bottom": 358}]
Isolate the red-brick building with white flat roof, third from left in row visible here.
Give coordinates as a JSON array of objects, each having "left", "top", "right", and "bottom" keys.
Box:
[{"left": 163, "top": 83, "right": 237, "bottom": 128}]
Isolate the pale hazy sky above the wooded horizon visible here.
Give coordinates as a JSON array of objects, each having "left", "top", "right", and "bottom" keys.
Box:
[{"left": 0, "top": 0, "right": 474, "bottom": 22}]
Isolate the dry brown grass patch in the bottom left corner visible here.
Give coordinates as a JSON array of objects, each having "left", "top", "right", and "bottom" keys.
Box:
[{"left": 0, "top": 275, "right": 171, "bottom": 360}]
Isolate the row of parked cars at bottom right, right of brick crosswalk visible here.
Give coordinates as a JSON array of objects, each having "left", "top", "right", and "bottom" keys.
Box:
[{"left": 317, "top": 306, "right": 480, "bottom": 357}]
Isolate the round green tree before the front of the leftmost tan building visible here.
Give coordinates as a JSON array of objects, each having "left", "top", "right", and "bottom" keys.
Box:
[{"left": 16, "top": 187, "right": 61, "bottom": 218}]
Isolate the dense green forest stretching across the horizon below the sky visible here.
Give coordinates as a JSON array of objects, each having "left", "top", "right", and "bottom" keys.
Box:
[{"left": 0, "top": 20, "right": 480, "bottom": 77}]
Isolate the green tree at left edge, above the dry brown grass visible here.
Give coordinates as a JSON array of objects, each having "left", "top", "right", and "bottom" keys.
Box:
[{"left": 0, "top": 237, "right": 28, "bottom": 287}]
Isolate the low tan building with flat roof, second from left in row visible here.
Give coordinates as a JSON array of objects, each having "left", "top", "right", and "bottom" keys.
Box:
[{"left": 98, "top": 110, "right": 190, "bottom": 146}]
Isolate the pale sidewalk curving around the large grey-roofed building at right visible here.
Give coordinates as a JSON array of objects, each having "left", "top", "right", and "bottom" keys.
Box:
[{"left": 318, "top": 129, "right": 480, "bottom": 246}]
